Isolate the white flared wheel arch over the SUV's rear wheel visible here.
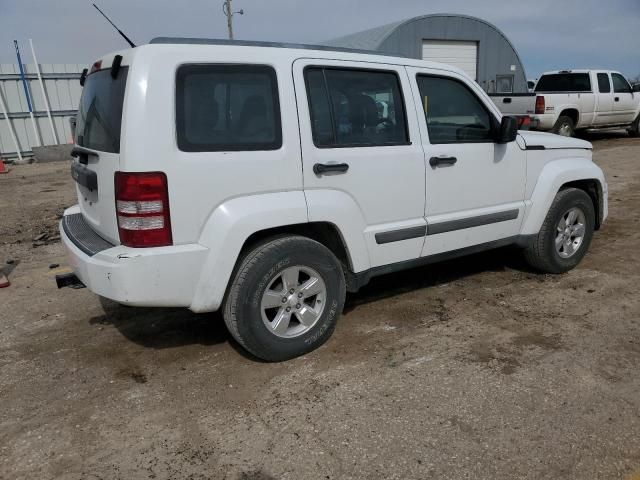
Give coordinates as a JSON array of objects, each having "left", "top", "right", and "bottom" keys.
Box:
[{"left": 189, "top": 191, "right": 370, "bottom": 312}]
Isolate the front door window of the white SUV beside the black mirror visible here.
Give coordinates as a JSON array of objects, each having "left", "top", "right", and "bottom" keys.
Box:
[{"left": 417, "top": 75, "right": 494, "bottom": 143}]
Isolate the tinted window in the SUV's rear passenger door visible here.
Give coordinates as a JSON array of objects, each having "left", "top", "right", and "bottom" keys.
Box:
[{"left": 305, "top": 67, "right": 409, "bottom": 147}]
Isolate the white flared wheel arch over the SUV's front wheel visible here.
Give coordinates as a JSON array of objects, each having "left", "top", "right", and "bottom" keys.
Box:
[{"left": 522, "top": 158, "right": 607, "bottom": 235}]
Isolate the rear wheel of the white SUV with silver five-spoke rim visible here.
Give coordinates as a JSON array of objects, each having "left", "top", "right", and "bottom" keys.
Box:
[{"left": 223, "top": 236, "right": 345, "bottom": 362}]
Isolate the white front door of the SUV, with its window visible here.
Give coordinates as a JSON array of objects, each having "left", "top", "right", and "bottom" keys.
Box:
[{"left": 407, "top": 68, "right": 526, "bottom": 256}]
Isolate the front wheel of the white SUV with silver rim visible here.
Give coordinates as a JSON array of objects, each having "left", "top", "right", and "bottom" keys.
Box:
[{"left": 524, "top": 188, "right": 595, "bottom": 273}]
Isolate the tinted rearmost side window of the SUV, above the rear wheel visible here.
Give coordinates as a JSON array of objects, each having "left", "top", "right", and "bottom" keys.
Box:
[{"left": 176, "top": 65, "right": 282, "bottom": 152}]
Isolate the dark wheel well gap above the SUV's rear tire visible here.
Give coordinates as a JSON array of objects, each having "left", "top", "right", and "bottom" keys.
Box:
[{"left": 240, "top": 222, "right": 353, "bottom": 271}]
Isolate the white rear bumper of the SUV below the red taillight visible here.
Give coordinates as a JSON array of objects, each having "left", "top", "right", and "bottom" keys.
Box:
[{"left": 60, "top": 207, "right": 208, "bottom": 307}]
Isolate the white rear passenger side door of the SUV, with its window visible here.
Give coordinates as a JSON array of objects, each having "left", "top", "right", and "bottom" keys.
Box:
[{"left": 293, "top": 59, "right": 426, "bottom": 271}]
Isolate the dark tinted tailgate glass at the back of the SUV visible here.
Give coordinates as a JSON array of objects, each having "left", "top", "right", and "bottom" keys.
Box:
[{"left": 76, "top": 67, "right": 129, "bottom": 153}]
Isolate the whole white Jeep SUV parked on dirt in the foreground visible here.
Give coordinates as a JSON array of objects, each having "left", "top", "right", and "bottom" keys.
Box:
[{"left": 58, "top": 38, "right": 607, "bottom": 361}]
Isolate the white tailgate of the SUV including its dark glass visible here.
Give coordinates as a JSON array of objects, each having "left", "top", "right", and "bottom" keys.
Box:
[{"left": 72, "top": 62, "right": 129, "bottom": 244}]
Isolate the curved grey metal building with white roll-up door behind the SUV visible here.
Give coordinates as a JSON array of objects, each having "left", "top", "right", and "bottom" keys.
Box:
[{"left": 324, "top": 14, "right": 528, "bottom": 93}]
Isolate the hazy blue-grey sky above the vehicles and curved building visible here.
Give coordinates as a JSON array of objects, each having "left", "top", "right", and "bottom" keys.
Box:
[{"left": 0, "top": 0, "right": 640, "bottom": 78}]
